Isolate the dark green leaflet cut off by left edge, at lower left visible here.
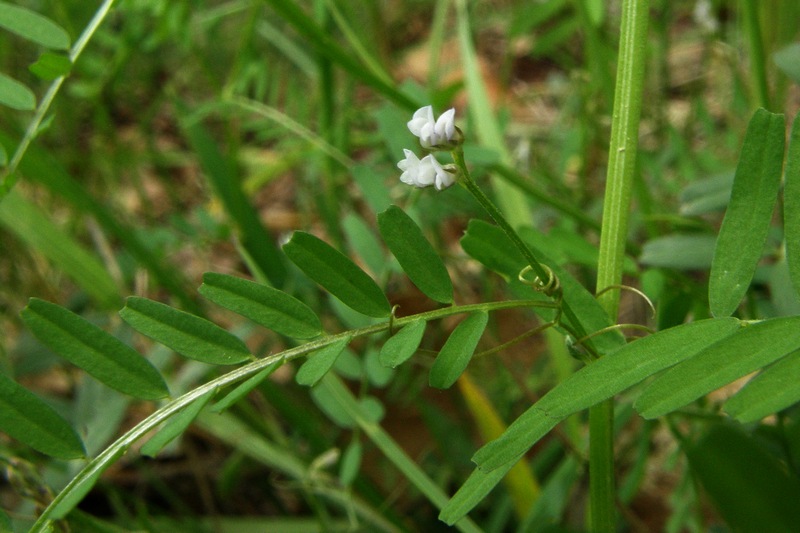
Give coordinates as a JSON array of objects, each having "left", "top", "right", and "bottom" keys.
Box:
[{"left": 0, "top": 374, "right": 86, "bottom": 459}]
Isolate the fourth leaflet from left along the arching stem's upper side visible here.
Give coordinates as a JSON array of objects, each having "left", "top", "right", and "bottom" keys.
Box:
[{"left": 199, "top": 272, "right": 322, "bottom": 339}]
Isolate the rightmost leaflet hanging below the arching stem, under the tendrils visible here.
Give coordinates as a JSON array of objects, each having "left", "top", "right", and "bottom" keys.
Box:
[{"left": 429, "top": 311, "right": 489, "bottom": 389}]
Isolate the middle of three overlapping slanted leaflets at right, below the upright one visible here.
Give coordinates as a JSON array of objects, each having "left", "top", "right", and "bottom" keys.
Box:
[{"left": 634, "top": 316, "right": 800, "bottom": 418}]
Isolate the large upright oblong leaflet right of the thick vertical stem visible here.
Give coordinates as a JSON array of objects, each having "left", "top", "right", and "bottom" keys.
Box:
[{"left": 708, "top": 109, "right": 786, "bottom": 317}]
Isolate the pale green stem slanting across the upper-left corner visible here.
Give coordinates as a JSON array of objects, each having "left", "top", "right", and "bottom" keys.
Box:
[{"left": 0, "top": 0, "right": 114, "bottom": 202}]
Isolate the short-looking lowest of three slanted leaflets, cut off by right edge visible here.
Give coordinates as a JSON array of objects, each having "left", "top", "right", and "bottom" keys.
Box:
[{"left": 725, "top": 351, "right": 800, "bottom": 424}]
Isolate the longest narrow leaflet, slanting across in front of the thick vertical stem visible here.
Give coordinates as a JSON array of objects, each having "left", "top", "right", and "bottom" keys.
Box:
[{"left": 472, "top": 318, "right": 740, "bottom": 470}]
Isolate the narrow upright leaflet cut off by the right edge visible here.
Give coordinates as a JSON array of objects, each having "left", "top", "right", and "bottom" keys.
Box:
[{"left": 783, "top": 112, "right": 800, "bottom": 298}]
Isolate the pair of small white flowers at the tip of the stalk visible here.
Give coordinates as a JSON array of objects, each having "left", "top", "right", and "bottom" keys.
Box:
[{"left": 397, "top": 106, "right": 462, "bottom": 191}]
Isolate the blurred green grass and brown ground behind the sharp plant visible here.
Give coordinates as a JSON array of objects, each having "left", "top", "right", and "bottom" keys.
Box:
[{"left": 0, "top": 0, "right": 800, "bottom": 531}]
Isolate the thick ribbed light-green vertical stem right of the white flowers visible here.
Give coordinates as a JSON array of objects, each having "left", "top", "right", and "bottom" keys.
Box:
[{"left": 589, "top": 0, "right": 649, "bottom": 533}]
